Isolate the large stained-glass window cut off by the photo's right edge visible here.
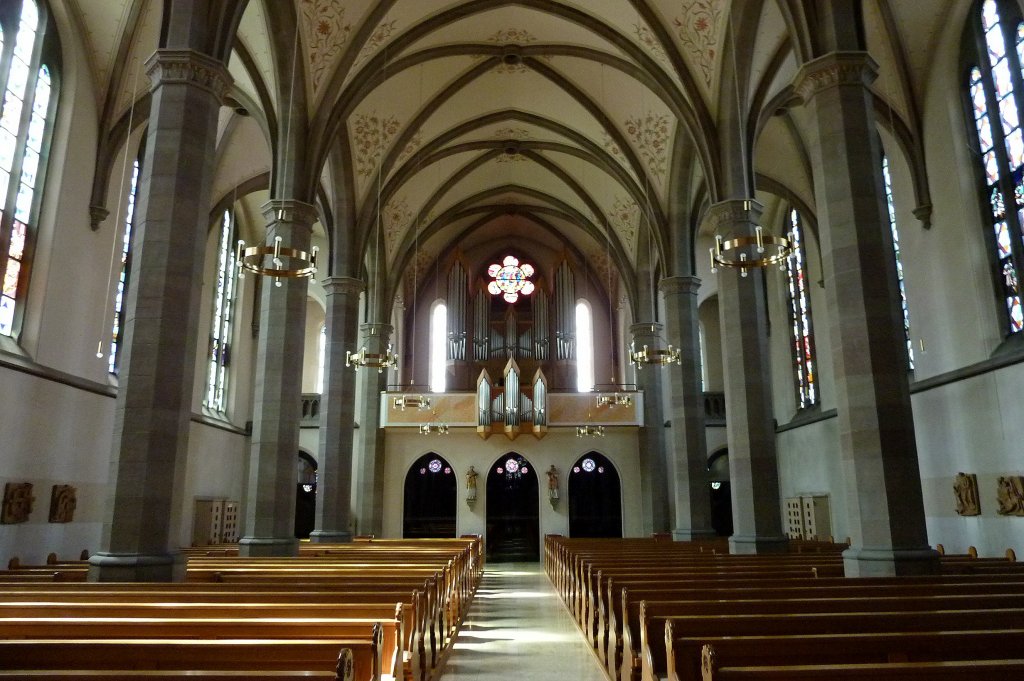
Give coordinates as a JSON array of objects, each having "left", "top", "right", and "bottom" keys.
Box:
[{"left": 964, "top": 0, "right": 1024, "bottom": 335}]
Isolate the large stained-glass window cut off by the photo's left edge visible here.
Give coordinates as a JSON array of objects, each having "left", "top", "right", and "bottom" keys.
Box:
[{"left": 0, "top": 0, "right": 59, "bottom": 337}]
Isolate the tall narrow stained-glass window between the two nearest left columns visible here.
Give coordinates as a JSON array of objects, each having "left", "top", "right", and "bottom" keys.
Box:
[{"left": 204, "top": 210, "right": 238, "bottom": 414}]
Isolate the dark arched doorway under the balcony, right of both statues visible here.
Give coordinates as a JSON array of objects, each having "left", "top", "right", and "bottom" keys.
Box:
[{"left": 568, "top": 452, "right": 623, "bottom": 537}]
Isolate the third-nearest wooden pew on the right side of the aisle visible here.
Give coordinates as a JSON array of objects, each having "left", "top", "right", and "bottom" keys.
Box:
[{"left": 630, "top": 594, "right": 1024, "bottom": 681}]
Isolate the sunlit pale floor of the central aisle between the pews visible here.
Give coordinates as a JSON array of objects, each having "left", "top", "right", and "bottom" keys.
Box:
[{"left": 440, "top": 563, "right": 606, "bottom": 681}]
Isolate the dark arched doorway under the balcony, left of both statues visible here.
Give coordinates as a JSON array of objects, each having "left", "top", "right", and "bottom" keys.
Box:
[{"left": 401, "top": 452, "right": 456, "bottom": 539}]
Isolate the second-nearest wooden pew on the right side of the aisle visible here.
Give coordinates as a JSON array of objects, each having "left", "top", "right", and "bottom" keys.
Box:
[{"left": 665, "top": 622, "right": 1024, "bottom": 681}]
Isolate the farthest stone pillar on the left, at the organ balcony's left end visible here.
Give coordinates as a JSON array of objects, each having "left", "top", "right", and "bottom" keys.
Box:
[{"left": 352, "top": 324, "right": 394, "bottom": 537}]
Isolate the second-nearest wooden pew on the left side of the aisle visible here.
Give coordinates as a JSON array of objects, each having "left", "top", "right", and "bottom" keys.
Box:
[{"left": 0, "top": 629, "right": 382, "bottom": 681}]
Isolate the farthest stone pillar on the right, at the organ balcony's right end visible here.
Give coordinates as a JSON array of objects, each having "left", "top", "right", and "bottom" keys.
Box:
[{"left": 630, "top": 322, "right": 672, "bottom": 535}]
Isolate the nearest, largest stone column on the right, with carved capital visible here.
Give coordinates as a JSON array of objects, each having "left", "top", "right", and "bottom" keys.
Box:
[{"left": 790, "top": 52, "right": 938, "bottom": 576}]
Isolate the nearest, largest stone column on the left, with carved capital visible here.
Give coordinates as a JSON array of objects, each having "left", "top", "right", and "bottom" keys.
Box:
[{"left": 89, "top": 49, "right": 231, "bottom": 582}]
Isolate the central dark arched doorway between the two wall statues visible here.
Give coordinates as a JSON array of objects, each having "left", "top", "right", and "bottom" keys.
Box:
[{"left": 487, "top": 453, "right": 541, "bottom": 562}]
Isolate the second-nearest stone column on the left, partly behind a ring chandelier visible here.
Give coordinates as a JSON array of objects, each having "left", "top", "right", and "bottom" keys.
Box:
[{"left": 239, "top": 199, "right": 316, "bottom": 556}]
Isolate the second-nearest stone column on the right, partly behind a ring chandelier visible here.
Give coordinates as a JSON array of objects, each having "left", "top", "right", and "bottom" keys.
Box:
[{"left": 705, "top": 200, "right": 788, "bottom": 553}]
